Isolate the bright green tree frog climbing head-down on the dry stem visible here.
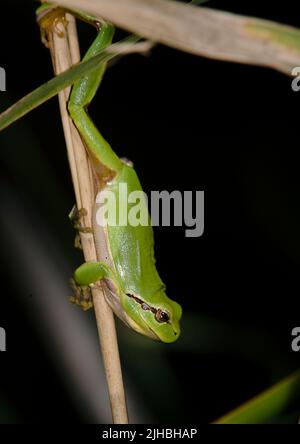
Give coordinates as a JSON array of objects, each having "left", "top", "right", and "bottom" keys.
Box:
[{"left": 37, "top": 4, "right": 182, "bottom": 343}]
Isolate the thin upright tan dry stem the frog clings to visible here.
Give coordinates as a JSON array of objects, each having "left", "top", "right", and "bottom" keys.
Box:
[{"left": 48, "top": 14, "right": 128, "bottom": 424}]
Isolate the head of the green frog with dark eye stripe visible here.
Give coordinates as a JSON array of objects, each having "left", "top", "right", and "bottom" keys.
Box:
[{"left": 124, "top": 291, "right": 182, "bottom": 343}]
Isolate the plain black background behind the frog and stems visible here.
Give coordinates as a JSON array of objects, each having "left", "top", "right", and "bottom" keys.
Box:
[{"left": 0, "top": 0, "right": 300, "bottom": 423}]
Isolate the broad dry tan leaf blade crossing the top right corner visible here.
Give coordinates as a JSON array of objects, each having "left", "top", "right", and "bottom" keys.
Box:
[{"left": 57, "top": 0, "right": 300, "bottom": 75}]
